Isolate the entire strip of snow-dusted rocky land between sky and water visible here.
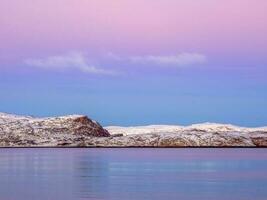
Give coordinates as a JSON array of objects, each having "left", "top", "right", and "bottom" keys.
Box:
[{"left": 0, "top": 113, "right": 267, "bottom": 147}]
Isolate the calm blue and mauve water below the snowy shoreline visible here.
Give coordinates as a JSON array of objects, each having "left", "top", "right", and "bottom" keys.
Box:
[{"left": 0, "top": 149, "right": 267, "bottom": 200}]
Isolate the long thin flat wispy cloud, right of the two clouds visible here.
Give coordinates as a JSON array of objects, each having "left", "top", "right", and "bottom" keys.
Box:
[{"left": 108, "top": 53, "right": 207, "bottom": 67}]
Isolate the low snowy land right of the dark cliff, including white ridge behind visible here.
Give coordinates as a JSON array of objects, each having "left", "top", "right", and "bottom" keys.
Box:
[{"left": 103, "top": 123, "right": 267, "bottom": 147}]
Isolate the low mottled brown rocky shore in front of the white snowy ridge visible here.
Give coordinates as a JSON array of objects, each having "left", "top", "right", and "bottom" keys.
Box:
[{"left": 86, "top": 131, "right": 256, "bottom": 147}]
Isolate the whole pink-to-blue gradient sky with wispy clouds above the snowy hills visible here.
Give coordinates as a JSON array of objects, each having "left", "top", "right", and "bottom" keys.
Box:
[{"left": 0, "top": 0, "right": 267, "bottom": 127}]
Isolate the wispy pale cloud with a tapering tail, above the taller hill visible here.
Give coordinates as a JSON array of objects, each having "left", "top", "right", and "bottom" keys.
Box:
[{"left": 25, "top": 52, "right": 116, "bottom": 75}]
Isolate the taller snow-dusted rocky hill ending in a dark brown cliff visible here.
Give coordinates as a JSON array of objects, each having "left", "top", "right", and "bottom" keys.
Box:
[{"left": 0, "top": 113, "right": 109, "bottom": 147}]
